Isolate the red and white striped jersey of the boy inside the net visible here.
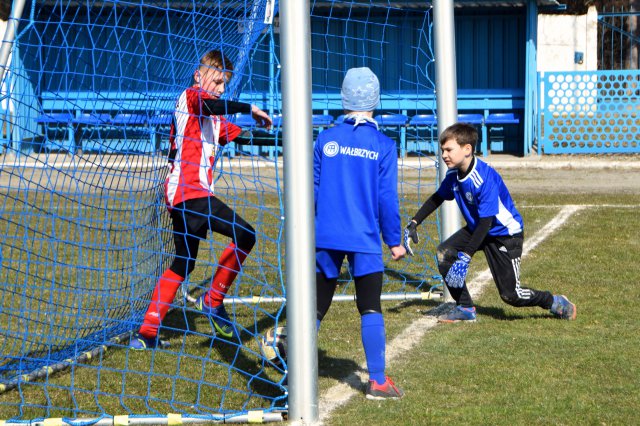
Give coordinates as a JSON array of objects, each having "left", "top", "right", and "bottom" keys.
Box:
[{"left": 165, "top": 86, "right": 241, "bottom": 208}]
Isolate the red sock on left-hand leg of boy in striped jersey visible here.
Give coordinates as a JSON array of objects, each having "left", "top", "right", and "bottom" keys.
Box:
[{"left": 138, "top": 269, "right": 184, "bottom": 339}]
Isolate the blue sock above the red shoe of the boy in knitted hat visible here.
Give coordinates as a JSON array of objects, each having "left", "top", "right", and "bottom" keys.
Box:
[{"left": 361, "top": 312, "right": 386, "bottom": 385}]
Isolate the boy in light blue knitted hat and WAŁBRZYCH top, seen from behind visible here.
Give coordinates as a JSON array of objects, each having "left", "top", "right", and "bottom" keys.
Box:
[{"left": 314, "top": 67, "right": 406, "bottom": 399}]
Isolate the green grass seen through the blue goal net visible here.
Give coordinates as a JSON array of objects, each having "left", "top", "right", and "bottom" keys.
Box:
[{"left": 0, "top": 179, "right": 435, "bottom": 419}]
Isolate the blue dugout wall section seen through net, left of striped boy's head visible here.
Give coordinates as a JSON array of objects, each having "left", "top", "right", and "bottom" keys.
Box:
[{"left": 19, "top": 2, "right": 261, "bottom": 93}]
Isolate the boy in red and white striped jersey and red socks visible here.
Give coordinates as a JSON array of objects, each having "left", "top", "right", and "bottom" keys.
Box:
[{"left": 130, "top": 50, "right": 272, "bottom": 350}]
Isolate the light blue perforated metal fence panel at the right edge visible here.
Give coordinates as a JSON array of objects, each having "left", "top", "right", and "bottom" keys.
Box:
[{"left": 538, "top": 70, "right": 640, "bottom": 154}]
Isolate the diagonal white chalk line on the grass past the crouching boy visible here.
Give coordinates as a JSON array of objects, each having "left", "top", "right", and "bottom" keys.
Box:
[{"left": 318, "top": 205, "right": 585, "bottom": 423}]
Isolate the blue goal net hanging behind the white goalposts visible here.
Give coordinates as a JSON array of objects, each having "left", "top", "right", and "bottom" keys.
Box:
[{"left": 0, "top": 0, "right": 441, "bottom": 424}]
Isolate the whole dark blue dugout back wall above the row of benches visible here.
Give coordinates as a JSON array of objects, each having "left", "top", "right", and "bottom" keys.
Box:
[{"left": 22, "top": 4, "right": 525, "bottom": 92}]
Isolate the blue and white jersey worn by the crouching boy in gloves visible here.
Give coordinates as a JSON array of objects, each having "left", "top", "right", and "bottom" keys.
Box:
[{"left": 437, "top": 157, "right": 524, "bottom": 236}]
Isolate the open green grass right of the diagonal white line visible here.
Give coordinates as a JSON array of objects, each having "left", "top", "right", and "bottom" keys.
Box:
[{"left": 320, "top": 195, "right": 640, "bottom": 425}]
